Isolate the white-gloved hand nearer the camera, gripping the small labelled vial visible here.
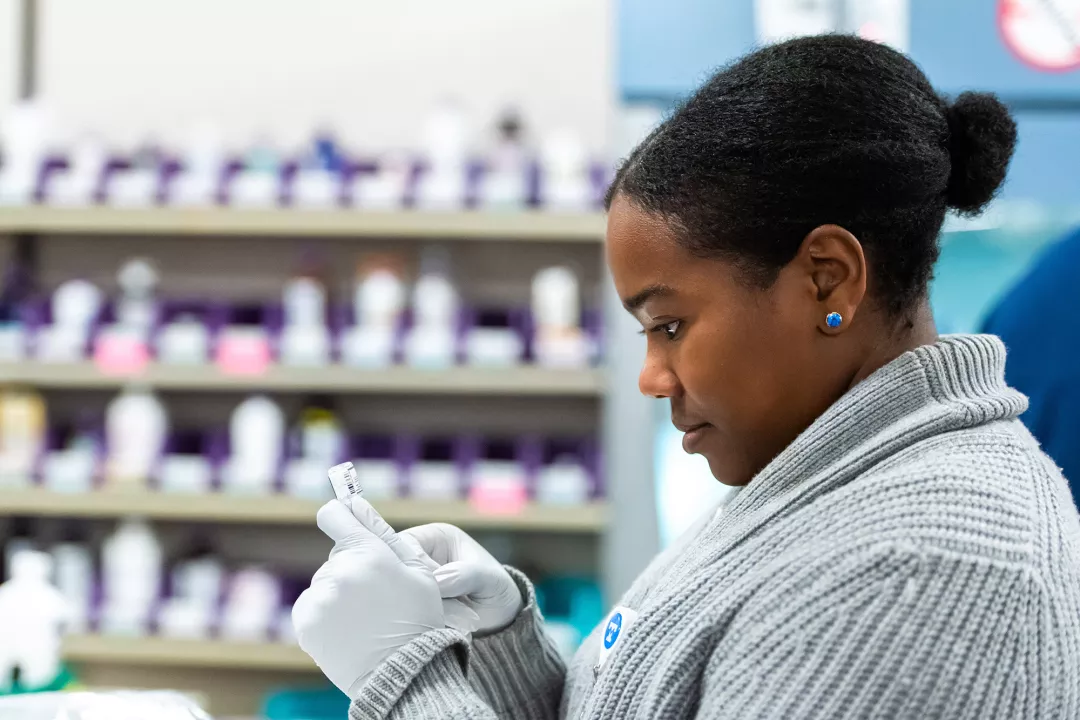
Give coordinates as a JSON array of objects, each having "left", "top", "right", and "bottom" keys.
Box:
[{"left": 293, "top": 498, "right": 481, "bottom": 699}]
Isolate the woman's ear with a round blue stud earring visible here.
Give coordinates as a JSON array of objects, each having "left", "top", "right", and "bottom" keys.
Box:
[{"left": 796, "top": 225, "right": 866, "bottom": 335}]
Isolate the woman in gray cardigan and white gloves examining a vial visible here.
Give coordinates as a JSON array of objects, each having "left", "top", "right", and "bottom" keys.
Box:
[{"left": 294, "top": 37, "right": 1080, "bottom": 720}]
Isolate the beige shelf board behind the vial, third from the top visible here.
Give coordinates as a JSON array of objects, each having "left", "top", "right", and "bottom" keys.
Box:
[{"left": 0, "top": 488, "right": 607, "bottom": 533}]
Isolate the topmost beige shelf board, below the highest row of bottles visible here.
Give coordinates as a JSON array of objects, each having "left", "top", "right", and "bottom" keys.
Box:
[{"left": 0, "top": 206, "right": 605, "bottom": 243}]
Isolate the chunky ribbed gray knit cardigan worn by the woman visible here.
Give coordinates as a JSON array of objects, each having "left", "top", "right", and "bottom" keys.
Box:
[{"left": 351, "top": 336, "right": 1080, "bottom": 720}]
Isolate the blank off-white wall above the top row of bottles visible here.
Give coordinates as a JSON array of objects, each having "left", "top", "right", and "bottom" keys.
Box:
[{"left": 25, "top": 0, "right": 615, "bottom": 148}]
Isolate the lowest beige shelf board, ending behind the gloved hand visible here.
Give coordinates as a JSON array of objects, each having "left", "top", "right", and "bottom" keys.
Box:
[{"left": 64, "top": 635, "right": 319, "bottom": 671}]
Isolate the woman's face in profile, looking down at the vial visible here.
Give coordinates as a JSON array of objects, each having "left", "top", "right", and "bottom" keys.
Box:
[{"left": 606, "top": 195, "right": 865, "bottom": 485}]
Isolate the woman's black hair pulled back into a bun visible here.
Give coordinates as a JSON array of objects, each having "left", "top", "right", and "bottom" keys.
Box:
[{"left": 607, "top": 35, "right": 1016, "bottom": 316}]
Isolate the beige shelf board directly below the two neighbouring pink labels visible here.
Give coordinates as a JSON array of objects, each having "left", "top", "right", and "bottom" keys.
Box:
[{"left": 0, "top": 362, "right": 604, "bottom": 397}]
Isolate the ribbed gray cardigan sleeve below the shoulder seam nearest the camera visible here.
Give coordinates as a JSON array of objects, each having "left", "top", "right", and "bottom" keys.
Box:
[{"left": 691, "top": 546, "right": 1062, "bottom": 720}]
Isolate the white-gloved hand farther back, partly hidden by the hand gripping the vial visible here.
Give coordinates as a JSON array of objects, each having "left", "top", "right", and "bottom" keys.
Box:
[{"left": 401, "top": 522, "right": 525, "bottom": 633}]
